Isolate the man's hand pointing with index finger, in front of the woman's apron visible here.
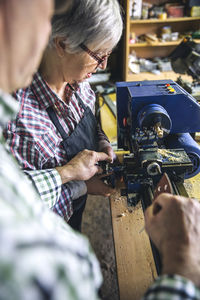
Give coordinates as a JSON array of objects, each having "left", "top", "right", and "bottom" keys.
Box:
[{"left": 56, "top": 150, "right": 109, "bottom": 183}]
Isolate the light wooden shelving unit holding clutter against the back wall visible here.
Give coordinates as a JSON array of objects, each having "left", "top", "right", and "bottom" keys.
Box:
[{"left": 123, "top": 0, "right": 200, "bottom": 81}]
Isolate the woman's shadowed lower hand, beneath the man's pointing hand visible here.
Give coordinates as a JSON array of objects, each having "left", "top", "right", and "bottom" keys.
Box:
[{"left": 85, "top": 176, "right": 115, "bottom": 197}]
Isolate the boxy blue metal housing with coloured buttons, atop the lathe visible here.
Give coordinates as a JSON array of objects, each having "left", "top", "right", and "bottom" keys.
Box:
[{"left": 116, "top": 80, "right": 200, "bottom": 148}]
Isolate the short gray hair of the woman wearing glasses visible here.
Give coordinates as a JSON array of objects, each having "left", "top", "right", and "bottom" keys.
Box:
[{"left": 49, "top": 0, "right": 123, "bottom": 53}]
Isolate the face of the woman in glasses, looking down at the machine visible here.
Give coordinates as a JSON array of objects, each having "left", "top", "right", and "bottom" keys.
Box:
[{"left": 59, "top": 43, "right": 111, "bottom": 83}]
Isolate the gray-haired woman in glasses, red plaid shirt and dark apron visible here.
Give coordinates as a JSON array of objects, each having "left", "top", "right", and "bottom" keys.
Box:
[{"left": 5, "top": 0, "right": 122, "bottom": 230}]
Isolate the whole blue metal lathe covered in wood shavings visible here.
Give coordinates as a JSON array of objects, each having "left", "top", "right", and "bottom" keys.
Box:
[{"left": 114, "top": 80, "right": 200, "bottom": 274}]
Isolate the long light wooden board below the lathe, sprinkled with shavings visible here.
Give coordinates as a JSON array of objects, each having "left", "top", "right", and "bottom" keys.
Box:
[{"left": 110, "top": 191, "right": 157, "bottom": 300}]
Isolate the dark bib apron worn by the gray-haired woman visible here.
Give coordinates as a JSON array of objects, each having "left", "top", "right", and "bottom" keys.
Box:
[{"left": 47, "top": 88, "right": 98, "bottom": 231}]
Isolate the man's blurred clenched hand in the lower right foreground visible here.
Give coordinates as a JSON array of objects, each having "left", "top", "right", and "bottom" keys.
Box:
[{"left": 145, "top": 194, "right": 200, "bottom": 286}]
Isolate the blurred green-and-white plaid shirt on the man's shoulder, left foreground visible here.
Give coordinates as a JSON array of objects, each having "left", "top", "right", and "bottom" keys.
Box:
[{"left": 0, "top": 92, "right": 102, "bottom": 300}]
